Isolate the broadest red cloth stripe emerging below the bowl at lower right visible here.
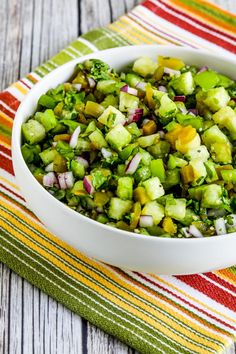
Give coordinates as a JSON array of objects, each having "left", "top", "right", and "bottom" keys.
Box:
[{"left": 176, "top": 274, "right": 236, "bottom": 311}]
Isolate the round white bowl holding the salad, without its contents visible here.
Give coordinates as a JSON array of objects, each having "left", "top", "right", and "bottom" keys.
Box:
[{"left": 12, "top": 45, "right": 236, "bottom": 274}]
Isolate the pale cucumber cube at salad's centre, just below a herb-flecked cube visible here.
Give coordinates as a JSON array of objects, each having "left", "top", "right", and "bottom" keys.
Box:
[{"left": 106, "top": 124, "right": 132, "bottom": 151}]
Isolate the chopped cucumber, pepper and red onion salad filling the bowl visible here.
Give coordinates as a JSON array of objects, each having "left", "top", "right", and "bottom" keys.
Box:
[{"left": 22, "top": 56, "right": 236, "bottom": 238}]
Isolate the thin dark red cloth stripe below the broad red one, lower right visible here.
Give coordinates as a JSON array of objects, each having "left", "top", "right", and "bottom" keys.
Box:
[{"left": 134, "top": 272, "right": 236, "bottom": 331}]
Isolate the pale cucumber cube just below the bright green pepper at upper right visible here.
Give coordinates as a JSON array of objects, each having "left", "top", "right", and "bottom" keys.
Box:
[{"left": 203, "top": 87, "right": 230, "bottom": 112}]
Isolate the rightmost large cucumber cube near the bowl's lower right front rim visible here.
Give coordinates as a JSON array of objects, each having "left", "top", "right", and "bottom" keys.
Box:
[{"left": 201, "top": 184, "right": 222, "bottom": 208}]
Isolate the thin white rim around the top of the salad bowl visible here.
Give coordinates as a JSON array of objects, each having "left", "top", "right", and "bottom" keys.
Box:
[{"left": 12, "top": 44, "right": 236, "bottom": 244}]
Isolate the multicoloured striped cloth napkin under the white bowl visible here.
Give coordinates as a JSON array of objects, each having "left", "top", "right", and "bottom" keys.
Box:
[{"left": 0, "top": 0, "right": 236, "bottom": 354}]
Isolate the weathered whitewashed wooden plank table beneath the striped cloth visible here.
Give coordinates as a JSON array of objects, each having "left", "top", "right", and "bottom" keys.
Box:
[{"left": 0, "top": 0, "right": 236, "bottom": 354}]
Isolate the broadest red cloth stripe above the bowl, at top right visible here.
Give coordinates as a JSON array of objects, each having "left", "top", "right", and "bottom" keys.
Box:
[{"left": 142, "top": 1, "right": 236, "bottom": 53}]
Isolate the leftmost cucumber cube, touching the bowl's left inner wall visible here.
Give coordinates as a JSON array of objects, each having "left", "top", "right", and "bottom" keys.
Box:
[{"left": 22, "top": 119, "right": 46, "bottom": 145}]
